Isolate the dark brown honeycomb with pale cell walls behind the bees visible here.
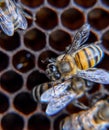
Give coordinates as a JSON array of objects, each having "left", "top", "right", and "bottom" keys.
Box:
[{"left": 0, "top": 0, "right": 109, "bottom": 130}]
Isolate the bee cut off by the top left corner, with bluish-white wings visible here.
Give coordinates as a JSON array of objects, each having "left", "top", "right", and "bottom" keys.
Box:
[{"left": 0, "top": 0, "right": 27, "bottom": 36}]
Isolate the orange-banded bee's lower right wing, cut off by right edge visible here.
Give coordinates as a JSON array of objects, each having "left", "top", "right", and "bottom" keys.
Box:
[{"left": 77, "top": 68, "right": 109, "bottom": 84}]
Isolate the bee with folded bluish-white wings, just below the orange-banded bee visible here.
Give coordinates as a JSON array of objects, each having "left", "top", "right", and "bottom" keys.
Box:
[{"left": 32, "top": 77, "right": 92, "bottom": 116}]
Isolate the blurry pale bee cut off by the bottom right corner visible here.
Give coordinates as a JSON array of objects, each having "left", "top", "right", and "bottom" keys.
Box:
[{"left": 60, "top": 100, "right": 109, "bottom": 130}]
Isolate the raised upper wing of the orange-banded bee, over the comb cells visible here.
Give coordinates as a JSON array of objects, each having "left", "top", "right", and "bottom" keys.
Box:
[{"left": 66, "top": 23, "right": 90, "bottom": 54}]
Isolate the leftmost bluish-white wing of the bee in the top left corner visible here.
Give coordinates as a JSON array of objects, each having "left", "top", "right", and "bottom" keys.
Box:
[{"left": 0, "top": 9, "right": 14, "bottom": 36}]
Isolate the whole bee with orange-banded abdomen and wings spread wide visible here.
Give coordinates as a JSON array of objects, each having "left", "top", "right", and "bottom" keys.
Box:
[{"left": 46, "top": 23, "right": 109, "bottom": 84}]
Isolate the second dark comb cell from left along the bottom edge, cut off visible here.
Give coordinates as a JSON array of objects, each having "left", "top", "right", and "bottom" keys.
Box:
[{"left": 28, "top": 113, "right": 50, "bottom": 130}]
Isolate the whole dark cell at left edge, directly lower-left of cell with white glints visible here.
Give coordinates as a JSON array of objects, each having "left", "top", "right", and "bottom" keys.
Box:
[{"left": 0, "top": 70, "right": 23, "bottom": 93}]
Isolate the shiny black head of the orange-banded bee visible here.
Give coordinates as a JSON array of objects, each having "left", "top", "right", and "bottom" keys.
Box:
[{"left": 46, "top": 63, "right": 61, "bottom": 80}]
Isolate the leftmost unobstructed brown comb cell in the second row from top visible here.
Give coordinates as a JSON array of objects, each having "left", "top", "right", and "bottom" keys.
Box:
[{"left": 36, "top": 7, "right": 58, "bottom": 30}]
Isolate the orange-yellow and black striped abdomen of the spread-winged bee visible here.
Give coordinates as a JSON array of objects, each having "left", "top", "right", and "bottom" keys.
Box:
[{"left": 74, "top": 44, "right": 104, "bottom": 70}]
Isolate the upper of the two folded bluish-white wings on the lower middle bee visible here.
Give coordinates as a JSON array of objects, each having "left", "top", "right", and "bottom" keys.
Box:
[{"left": 41, "top": 80, "right": 71, "bottom": 102}]
